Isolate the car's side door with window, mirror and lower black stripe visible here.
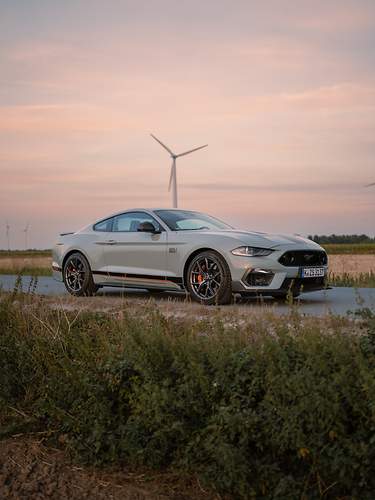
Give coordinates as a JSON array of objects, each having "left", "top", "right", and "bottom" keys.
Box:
[{"left": 104, "top": 211, "right": 173, "bottom": 288}]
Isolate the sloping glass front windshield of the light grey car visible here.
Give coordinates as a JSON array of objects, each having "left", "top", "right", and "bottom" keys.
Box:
[{"left": 155, "top": 210, "right": 233, "bottom": 231}]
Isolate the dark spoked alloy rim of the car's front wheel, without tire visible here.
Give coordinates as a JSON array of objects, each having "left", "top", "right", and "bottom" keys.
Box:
[{"left": 190, "top": 257, "right": 222, "bottom": 300}]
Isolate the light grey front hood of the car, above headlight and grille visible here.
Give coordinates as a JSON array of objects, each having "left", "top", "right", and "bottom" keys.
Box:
[{"left": 207, "top": 229, "right": 321, "bottom": 250}]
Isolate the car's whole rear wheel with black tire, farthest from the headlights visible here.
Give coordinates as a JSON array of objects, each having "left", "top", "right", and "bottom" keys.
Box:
[{"left": 63, "top": 252, "right": 100, "bottom": 297}]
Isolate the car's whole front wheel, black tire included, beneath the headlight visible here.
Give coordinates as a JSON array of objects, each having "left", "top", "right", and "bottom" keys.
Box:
[{"left": 186, "top": 250, "right": 232, "bottom": 305}]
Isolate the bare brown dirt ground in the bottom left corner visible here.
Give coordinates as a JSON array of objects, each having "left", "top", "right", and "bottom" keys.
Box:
[{"left": 0, "top": 437, "right": 217, "bottom": 500}]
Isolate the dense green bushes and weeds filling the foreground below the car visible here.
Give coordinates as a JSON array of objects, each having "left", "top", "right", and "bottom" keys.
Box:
[{"left": 0, "top": 294, "right": 375, "bottom": 499}]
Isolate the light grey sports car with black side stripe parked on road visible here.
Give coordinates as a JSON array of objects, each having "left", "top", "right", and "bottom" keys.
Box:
[{"left": 52, "top": 209, "right": 327, "bottom": 304}]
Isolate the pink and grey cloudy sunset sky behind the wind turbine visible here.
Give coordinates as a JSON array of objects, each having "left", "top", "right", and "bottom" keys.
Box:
[{"left": 0, "top": 0, "right": 375, "bottom": 248}]
